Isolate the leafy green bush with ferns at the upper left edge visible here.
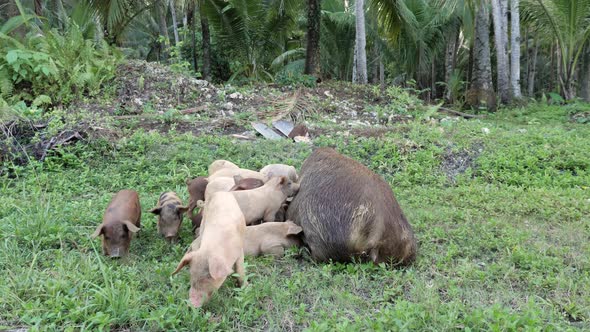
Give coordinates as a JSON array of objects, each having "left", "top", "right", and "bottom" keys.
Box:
[{"left": 0, "top": 20, "right": 122, "bottom": 115}]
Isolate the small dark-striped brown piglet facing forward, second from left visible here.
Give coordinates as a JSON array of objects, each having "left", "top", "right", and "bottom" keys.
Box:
[{"left": 150, "top": 191, "right": 188, "bottom": 242}]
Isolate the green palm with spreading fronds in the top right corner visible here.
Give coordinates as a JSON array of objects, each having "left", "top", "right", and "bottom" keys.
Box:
[{"left": 521, "top": 0, "right": 590, "bottom": 100}]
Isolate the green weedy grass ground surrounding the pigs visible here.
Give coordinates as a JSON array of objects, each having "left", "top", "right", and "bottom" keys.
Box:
[{"left": 0, "top": 100, "right": 590, "bottom": 331}]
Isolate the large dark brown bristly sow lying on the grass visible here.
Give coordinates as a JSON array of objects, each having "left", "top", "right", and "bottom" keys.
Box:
[{"left": 287, "top": 148, "right": 417, "bottom": 264}]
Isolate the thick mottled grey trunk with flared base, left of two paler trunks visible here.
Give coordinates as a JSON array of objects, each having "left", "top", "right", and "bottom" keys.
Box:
[{"left": 466, "top": 0, "right": 496, "bottom": 110}]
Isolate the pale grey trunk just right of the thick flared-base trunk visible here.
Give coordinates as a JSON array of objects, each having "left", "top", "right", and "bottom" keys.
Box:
[{"left": 492, "top": 0, "right": 510, "bottom": 104}]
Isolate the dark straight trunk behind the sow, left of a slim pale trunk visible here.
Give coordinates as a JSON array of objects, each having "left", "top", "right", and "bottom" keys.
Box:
[{"left": 305, "top": 0, "right": 322, "bottom": 77}]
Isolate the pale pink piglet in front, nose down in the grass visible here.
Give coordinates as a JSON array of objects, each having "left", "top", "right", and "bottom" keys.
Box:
[{"left": 172, "top": 192, "right": 246, "bottom": 308}]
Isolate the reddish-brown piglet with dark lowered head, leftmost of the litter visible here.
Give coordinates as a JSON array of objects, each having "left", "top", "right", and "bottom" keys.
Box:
[{"left": 91, "top": 190, "right": 141, "bottom": 257}]
